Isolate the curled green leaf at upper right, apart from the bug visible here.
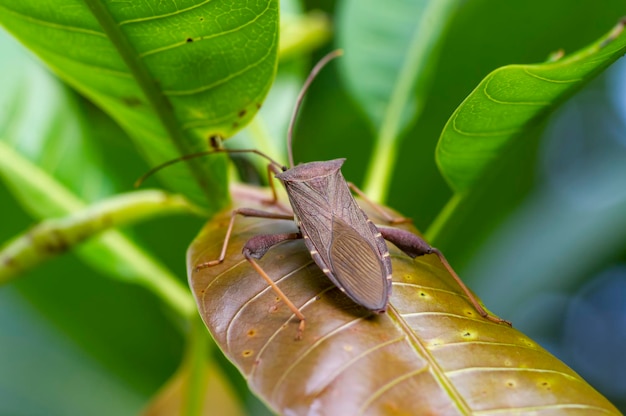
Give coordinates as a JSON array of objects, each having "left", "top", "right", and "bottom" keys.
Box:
[{"left": 437, "top": 22, "right": 626, "bottom": 193}]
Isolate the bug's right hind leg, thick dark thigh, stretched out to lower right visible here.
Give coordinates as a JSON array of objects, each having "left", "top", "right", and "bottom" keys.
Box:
[{"left": 378, "top": 227, "right": 512, "bottom": 326}]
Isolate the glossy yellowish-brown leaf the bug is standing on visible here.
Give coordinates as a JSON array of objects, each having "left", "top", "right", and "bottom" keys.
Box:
[{"left": 187, "top": 189, "right": 620, "bottom": 415}]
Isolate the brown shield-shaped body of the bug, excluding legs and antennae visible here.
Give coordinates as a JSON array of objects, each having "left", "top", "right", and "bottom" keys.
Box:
[{"left": 276, "top": 159, "right": 391, "bottom": 312}]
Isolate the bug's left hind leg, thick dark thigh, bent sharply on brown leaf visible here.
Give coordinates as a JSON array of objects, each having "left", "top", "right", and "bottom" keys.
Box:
[{"left": 243, "top": 233, "right": 305, "bottom": 339}]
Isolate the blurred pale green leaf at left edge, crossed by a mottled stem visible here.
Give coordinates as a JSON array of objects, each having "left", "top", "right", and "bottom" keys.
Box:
[{"left": 0, "top": 32, "right": 194, "bottom": 317}]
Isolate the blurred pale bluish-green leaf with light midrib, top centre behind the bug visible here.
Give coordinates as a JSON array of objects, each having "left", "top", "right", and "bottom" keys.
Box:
[{"left": 338, "top": 0, "right": 459, "bottom": 200}]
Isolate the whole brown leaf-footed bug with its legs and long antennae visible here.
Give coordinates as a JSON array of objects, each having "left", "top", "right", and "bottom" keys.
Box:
[{"left": 140, "top": 51, "right": 511, "bottom": 338}]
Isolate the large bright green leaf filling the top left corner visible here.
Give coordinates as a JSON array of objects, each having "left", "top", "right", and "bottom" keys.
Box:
[{"left": 0, "top": 0, "right": 278, "bottom": 209}]
